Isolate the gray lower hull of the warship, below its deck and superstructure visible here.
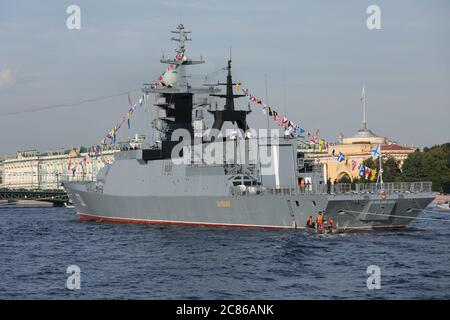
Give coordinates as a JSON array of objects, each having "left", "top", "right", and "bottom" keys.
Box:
[{"left": 65, "top": 183, "right": 434, "bottom": 231}]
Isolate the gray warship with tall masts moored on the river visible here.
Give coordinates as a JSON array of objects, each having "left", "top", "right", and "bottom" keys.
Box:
[{"left": 63, "top": 24, "right": 435, "bottom": 231}]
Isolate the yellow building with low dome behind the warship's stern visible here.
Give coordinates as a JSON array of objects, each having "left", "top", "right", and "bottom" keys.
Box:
[{"left": 307, "top": 122, "right": 414, "bottom": 182}]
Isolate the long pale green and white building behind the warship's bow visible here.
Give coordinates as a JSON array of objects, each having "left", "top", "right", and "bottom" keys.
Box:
[{"left": 0, "top": 135, "right": 145, "bottom": 189}]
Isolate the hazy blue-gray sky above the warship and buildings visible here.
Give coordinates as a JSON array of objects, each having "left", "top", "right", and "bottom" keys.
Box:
[{"left": 0, "top": 0, "right": 450, "bottom": 156}]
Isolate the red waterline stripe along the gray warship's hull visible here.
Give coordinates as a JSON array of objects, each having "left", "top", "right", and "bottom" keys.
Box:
[{"left": 77, "top": 212, "right": 293, "bottom": 230}]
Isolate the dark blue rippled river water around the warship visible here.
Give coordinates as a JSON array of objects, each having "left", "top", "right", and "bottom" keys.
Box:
[{"left": 0, "top": 206, "right": 450, "bottom": 299}]
